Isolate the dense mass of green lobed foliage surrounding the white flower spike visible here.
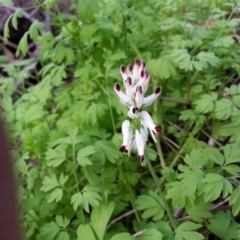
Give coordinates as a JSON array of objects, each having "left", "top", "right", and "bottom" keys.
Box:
[{"left": 0, "top": 0, "right": 240, "bottom": 240}]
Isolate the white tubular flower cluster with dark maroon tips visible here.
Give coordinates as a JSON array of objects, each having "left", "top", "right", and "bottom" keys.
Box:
[{"left": 114, "top": 59, "right": 162, "bottom": 163}]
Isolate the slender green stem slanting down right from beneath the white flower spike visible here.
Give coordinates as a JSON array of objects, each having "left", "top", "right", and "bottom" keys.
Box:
[{"left": 147, "top": 158, "right": 177, "bottom": 229}]
